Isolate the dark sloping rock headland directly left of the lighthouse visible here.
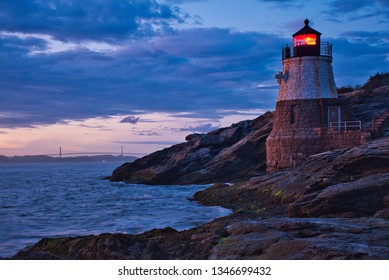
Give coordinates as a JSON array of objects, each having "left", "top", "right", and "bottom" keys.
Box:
[{"left": 108, "top": 113, "right": 272, "bottom": 185}]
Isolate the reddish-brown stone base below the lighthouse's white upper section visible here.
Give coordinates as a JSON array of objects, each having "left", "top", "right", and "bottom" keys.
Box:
[{"left": 266, "top": 98, "right": 366, "bottom": 171}]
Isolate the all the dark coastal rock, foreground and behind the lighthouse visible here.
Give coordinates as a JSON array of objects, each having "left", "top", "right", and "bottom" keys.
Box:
[{"left": 13, "top": 86, "right": 389, "bottom": 259}]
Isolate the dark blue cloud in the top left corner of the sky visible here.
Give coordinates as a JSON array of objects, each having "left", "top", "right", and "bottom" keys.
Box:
[{"left": 0, "top": 0, "right": 182, "bottom": 41}]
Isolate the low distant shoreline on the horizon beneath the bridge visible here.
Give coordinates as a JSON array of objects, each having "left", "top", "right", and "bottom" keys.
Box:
[{"left": 0, "top": 155, "right": 137, "bottom": 164}]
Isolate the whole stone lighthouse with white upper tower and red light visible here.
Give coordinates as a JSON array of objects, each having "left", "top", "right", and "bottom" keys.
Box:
[{"left": 266, "top": 19, "right": 361, "bottom": 171}]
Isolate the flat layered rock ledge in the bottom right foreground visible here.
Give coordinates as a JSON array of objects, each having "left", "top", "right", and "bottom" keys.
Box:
[{"left": 209, "top": 218, "right": 389, "bottom": 259}]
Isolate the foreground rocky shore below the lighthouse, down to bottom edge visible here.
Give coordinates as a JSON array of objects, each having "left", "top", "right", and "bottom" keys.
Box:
[{"left": 13, "top": 138, "right": 389, "bottom": 259}]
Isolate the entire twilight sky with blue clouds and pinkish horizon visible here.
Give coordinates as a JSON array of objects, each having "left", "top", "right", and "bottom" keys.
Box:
[{"left": 0, "top": 0, "right": 389, "bottom": 156}]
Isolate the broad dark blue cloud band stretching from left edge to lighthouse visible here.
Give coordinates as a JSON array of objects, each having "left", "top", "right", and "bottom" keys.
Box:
[{"left": 0, "top": 28, "right": 281, "bottom": 127}]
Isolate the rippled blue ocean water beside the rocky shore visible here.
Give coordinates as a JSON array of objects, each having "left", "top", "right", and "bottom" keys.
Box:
[{"left": 0, "top": 163, "right": 230, "bottom": 258}]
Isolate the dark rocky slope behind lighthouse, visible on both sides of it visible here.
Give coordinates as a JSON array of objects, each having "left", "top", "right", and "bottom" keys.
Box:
[{"left": 109, "top": 85, "right": 389, "bottom": 185}]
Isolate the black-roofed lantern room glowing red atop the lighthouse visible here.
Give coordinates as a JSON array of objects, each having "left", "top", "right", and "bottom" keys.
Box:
[{"left": 292, "top": 19, "right": 321, "bottom": 57}]
